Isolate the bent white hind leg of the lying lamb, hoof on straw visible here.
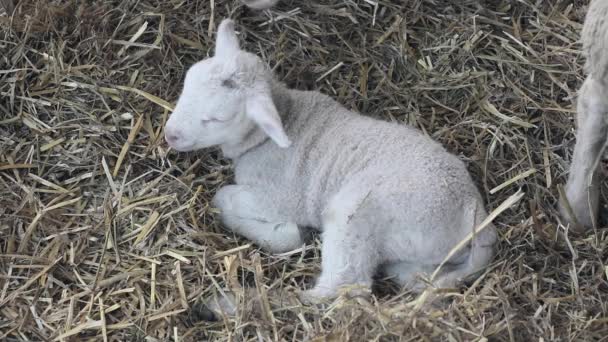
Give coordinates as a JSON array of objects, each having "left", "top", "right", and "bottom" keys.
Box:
[{"left": 302, "top": 191, "right": 379, "bottom": 302}]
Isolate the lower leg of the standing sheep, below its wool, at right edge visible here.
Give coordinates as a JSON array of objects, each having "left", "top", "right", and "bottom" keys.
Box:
[{"left": 560, "top": 76, "right": 608, "bottom": 227}]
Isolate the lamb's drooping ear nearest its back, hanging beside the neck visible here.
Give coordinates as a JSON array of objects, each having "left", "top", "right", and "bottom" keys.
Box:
[{"left": 246, "top": 93, "right": 291, "bottom": 148}]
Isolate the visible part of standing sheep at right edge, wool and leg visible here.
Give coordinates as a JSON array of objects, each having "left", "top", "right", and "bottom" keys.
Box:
[{"left": 560, "top": 0, "right": 608, "bottom": 227}]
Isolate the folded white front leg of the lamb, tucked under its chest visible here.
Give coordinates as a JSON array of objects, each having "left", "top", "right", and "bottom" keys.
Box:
[{"left": 213, "top": 185, "right": 304, "bottom": 253}]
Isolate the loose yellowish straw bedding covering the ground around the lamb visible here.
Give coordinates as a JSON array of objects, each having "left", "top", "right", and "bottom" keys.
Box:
[{"left": 0, "top": 0, "right": 608, "bottom": 341}]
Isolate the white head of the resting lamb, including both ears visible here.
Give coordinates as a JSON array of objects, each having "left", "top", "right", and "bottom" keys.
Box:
[{"left": 165, "top": 19, "right": 290, "bottom": 151}]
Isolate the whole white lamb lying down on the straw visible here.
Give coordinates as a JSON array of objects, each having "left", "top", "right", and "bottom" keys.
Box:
[{"left": 165, "top": 19, "right": 497, "bottom": 303}]
